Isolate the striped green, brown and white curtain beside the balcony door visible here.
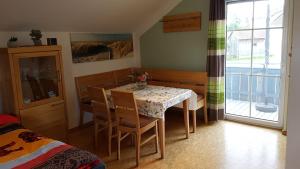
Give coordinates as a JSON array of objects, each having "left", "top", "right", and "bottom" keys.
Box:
[{"left": 207, "top": 0, "right": 225, "bottom": 120}]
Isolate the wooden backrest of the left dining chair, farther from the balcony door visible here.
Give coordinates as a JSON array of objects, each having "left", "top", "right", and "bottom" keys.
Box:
[{"left": 88, "top": 87, "right": 112, "bottom": 123}]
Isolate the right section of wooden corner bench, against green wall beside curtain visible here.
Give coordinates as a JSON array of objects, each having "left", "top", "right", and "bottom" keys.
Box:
[{"left": 143, "top": 69, "right": 208, "bottom": 131}]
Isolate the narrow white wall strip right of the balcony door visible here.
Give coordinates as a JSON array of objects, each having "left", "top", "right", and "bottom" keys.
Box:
[{"left": 286, "top": 0, "right": 300, "bottom": 169}]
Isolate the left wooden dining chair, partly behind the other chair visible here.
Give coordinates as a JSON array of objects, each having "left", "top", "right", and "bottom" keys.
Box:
[{"left": 88, "top": 87, "right": 117, "bottom": 156}]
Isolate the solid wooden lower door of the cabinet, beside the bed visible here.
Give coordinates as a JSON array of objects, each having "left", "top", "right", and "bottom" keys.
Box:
[{"left": 20, "top": 101, "right": 66, "bottom": 141}]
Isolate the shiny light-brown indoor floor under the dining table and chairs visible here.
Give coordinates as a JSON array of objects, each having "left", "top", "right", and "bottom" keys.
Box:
[{"left": 70, "top": 111, "right": 286, "bottom": 169}]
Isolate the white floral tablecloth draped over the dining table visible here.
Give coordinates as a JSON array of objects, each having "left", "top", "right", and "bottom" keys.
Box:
[{"left": 107, "top": 84, "right": 197, "bottom": 119}]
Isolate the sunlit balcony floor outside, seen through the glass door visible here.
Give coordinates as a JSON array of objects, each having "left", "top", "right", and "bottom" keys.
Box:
[{"left": 226, "top": 99, "right": 278, "bottom": 121}]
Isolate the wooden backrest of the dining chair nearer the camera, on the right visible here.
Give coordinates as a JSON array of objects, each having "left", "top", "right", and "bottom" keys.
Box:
[{"left": 111, "top": 90, "right": 140, "bottom": 128}]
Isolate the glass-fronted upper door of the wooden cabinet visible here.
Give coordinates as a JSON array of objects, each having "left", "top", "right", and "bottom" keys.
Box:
[{"left": 13, "top": 52, "right": 63, "bottom": 109}]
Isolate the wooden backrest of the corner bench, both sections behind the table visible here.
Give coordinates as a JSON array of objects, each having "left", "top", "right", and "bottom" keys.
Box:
[{"left": 75, "top": 68, "right": 208, "bottom": 101}]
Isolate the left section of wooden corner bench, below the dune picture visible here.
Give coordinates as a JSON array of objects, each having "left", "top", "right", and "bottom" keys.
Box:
[{"left": 75, "top": 68, "right": 134, "bottom": 125}]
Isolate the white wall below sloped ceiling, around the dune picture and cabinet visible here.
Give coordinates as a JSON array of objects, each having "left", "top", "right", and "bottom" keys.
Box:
[{"left": 0, "top": 32, "right": 140, "bottom": 128}]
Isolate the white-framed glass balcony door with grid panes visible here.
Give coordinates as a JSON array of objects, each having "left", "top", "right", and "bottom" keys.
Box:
[{"left": 225, "top": 0, "right": 286, "bottom": 127}]
